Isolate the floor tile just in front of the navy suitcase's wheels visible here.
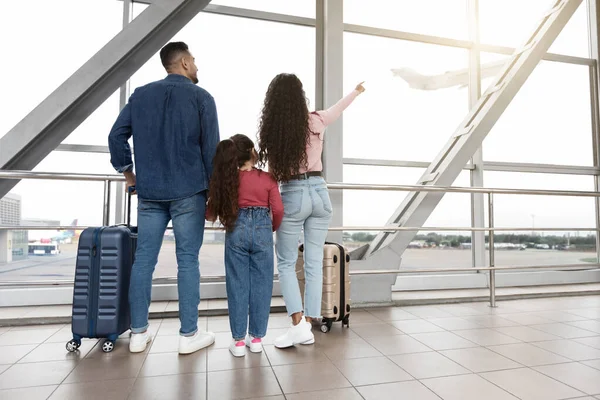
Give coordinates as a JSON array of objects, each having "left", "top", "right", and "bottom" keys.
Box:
[{"left": 64, "top": 357, "right": 144, "bottom": 383}]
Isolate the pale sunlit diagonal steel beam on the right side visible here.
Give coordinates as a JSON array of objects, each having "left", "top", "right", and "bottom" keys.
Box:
[{"left": 363, "top": 0, "right": 582, "bottom": 258}]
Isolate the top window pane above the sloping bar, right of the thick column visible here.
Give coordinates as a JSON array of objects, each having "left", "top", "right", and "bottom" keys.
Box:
[{"left": 344, "top": 0, "right": 469, "bottom": 39}]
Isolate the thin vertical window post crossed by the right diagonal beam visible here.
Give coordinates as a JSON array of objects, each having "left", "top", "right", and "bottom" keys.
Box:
[{"left": 468, "top": 0, "right": 485, "bottom": 268}]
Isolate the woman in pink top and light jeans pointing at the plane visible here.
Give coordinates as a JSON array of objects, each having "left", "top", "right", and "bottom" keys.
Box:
[{"left": 258, "top": 74, "right": 365, "bottom": 348}]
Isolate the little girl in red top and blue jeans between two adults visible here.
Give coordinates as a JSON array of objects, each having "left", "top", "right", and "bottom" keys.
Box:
[{"left": 207, "top": 135, "right": 283, "bottom": 357}]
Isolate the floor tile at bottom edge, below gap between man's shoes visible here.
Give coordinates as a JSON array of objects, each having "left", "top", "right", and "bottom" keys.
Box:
[{"left": 129, "top": 373, "right": 209, "bottom": 400}]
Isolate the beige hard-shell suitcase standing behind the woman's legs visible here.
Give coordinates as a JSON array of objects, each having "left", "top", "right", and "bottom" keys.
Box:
[{"left": 296, "top": 243, "right": 350, "bottom": 333}]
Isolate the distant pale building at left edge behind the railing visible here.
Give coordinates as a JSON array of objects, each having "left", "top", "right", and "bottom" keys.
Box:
[{"left": 0, "top": 193, "right": 28, "bottom": 263}]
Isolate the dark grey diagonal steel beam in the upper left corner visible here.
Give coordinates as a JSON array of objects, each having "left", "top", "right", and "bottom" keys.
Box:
[{"left": 0, "top": 0, "right": 210, "bottom": 198}]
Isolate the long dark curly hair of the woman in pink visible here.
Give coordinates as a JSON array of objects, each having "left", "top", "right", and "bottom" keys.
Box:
[{"left": 258, "top": 74, "right": 310, "bottom": 182}]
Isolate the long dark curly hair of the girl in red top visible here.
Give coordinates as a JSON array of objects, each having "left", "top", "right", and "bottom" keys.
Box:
[{"left": 207, "top": 134, "right": 256, "bottom": 231}]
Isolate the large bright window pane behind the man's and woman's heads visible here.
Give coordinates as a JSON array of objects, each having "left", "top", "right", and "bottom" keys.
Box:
[{"left": 131, "top": 14, "right": 315, "bottom": 140}]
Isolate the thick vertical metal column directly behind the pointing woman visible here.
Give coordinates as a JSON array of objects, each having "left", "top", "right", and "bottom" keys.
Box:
[{"left": 316, "top": 0, "right": 344, "bottom": 243}]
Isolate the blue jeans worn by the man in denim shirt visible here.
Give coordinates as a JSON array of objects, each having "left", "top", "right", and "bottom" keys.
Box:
[{"left": 129, "top": 192, "right": 206, "bottom": 336}]
